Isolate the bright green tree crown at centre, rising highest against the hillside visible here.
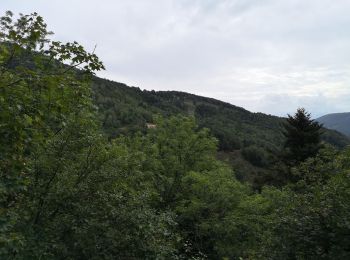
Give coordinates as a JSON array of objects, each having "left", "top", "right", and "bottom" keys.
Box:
[{"left": 149, "top": 117, "right": 216, "bottom": 207}]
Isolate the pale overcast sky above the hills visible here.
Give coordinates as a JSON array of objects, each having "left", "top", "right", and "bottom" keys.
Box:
[{"left": 0, "top": 0, "right": 350, "bottom": 117}]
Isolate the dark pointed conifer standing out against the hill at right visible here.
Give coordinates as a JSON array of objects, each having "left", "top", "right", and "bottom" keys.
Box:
[{"left": 283, "top": 108, "right": 322, "bottom": 164}]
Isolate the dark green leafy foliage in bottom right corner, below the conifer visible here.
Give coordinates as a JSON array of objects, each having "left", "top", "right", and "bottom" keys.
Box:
[{"left": 253, "top": 149, "right": 350, "bottom": 259}]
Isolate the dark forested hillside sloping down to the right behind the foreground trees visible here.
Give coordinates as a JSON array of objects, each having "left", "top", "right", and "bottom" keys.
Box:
[{"left": 93, "top": 77, "right": 350, "bottom": 181}]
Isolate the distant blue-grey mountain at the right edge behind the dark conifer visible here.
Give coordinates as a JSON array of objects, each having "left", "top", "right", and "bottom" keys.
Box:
[{"left": 316, "top": 112, "right": 350, "bottom": 137}]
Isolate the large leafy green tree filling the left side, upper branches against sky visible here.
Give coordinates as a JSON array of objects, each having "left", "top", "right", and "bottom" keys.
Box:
[{"left": 0, "top": 12, "right": 176, "bottom": 259}]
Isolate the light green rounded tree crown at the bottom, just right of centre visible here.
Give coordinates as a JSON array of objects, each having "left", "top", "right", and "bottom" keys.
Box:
[{"left": 176, "top": 169, "right": 251, "bottom": 259}]
